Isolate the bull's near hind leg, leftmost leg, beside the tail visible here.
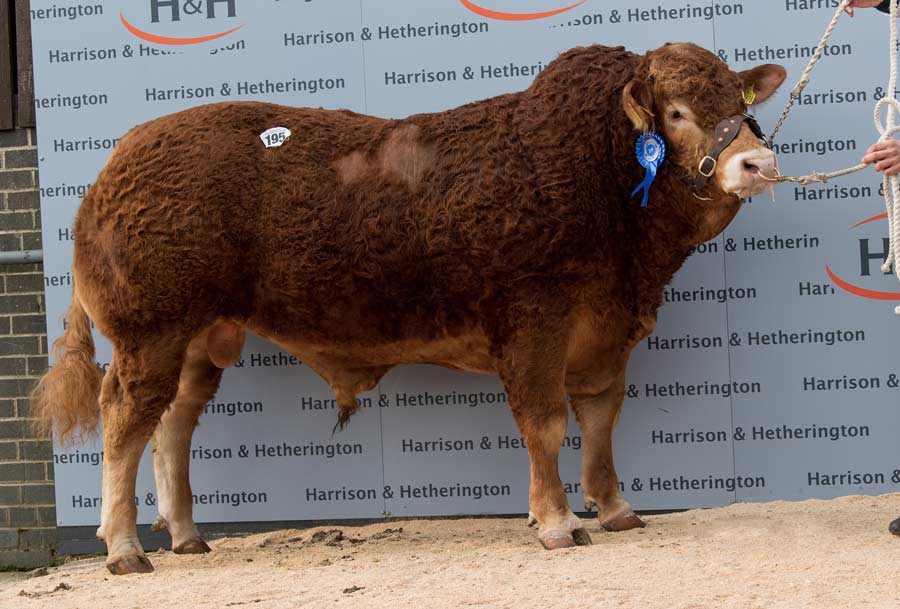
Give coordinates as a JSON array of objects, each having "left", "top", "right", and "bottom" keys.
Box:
[{"left": 97, "top": 338, "right": 185, "bottom": 575}]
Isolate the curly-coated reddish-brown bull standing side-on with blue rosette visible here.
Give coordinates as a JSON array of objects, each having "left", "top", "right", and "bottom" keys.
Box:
[{"left": 34, "top": 44, "right": 785, "bottom": 573}]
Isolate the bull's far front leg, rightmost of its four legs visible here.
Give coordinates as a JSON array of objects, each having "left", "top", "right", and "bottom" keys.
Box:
[{"left": 572, "top": 375, "right": 644, "bottom": 531}]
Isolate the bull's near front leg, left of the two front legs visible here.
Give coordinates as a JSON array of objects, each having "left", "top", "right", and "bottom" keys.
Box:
[{"left": 500, "top": 326, "right": 591, "bottom": 550}]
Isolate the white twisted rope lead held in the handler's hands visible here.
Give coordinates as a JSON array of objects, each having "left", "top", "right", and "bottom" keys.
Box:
[{"left": 763, "top": 0, "right": 900, "bottom": 315}]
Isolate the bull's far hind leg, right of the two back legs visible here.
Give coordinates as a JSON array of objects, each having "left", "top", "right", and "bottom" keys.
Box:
[{"left": 150, "top": 329, "right": 232, "bottom": 554}]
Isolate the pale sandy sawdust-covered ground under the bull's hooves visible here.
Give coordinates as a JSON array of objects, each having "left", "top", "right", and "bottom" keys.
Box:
[{"left": 0, "top": 494, "right": 900, "bottom": 609}]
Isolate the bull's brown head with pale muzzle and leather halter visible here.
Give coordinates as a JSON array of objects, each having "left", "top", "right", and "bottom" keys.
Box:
[{"left": 622, "top": 43, "right": 786, "bottom": 202}]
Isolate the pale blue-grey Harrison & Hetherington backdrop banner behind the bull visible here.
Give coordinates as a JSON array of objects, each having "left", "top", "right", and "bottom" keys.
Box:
[{"left": 31, "top": 0, "right": 900, "bottom": 526}]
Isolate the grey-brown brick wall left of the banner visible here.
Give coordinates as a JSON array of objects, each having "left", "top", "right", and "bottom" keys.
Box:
[{"left": 0, "top": 129, "right": 56, "bottom": 567}]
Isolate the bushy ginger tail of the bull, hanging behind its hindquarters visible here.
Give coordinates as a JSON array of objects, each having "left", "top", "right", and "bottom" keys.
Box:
[{"left": 31, "top": 292, "right": 103, "bottom": 444}]
